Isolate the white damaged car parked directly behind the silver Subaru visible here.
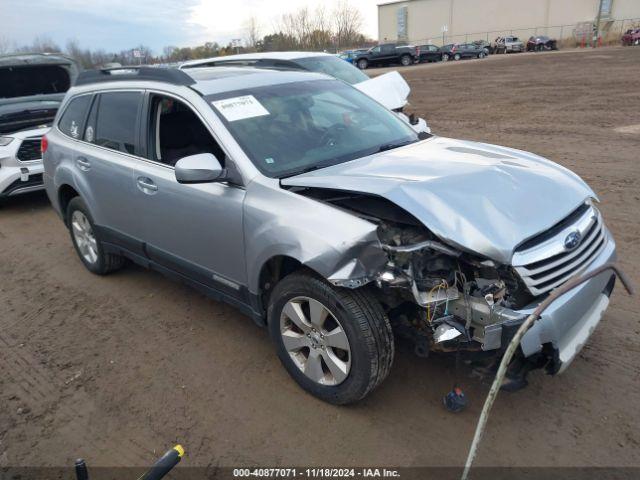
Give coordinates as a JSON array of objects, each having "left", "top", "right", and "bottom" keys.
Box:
[{"left": 178, "top": 52, "right": 431, "bottom": 133}]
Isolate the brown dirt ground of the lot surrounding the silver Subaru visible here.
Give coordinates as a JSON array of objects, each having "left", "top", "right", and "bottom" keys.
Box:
[{"left": 0, "top": 47, "right": 640, "bottom": 472}]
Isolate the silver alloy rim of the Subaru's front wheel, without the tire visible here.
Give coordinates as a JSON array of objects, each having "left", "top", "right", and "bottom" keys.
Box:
[{"left": 280, "top": 297, "right": 351, "bottom": 385}]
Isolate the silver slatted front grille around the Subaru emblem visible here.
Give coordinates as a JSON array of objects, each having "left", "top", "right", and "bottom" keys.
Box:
[{"left": 512, "top": 204, "right": 607, "bottom": 296}]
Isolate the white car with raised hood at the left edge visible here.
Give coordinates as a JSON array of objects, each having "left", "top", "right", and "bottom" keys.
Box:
[{"left": 0, "top": 53, "right": 78, "bottom": 198}]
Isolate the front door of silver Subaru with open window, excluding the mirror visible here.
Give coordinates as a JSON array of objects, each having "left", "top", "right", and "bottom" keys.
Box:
[{"left": 132, "top": 92, "right": 246, "bottom": 300}]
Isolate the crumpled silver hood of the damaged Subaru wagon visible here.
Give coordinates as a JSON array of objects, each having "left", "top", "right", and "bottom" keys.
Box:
[{"left": 282, "top": 137, "right": 595, "bottom": 264}]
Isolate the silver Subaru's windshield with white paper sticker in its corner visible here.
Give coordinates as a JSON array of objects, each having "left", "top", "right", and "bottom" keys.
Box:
[{"left": 206, "top": 79, "right": 418, "bottom": 178}]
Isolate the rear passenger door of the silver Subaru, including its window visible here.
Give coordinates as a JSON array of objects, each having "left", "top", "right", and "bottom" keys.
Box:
[{"left": 72, "top": 90, "right": 143, "bottom": 252}]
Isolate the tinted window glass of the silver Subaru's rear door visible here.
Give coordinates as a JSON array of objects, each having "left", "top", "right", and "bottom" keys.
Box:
[{"left": 93, "top": 92, "right": 142, "bottom": 155}]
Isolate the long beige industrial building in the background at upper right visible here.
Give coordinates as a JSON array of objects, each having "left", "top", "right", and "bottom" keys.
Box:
[{"left": 378, "top": 0, "right": 640, "bottom": 44}]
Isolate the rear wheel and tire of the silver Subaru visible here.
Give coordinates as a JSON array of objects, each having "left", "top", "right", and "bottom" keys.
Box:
[{"left": 65, "top": 197, "right": 125, "bottom": 275}]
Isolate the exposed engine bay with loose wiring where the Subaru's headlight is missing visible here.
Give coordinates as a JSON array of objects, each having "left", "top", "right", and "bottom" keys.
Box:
[{"left": 295, "top": 188, "right": 534, "bottom": 356}]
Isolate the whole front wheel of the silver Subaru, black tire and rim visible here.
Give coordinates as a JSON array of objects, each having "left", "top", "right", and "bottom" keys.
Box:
[{"left": 268, "top": 272, "right": 394, "bottom": 405}]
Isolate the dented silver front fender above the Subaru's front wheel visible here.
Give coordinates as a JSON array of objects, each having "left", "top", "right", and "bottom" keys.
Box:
[{"left": 244, "top": 181, "right": 387, "bottom": 293}]
